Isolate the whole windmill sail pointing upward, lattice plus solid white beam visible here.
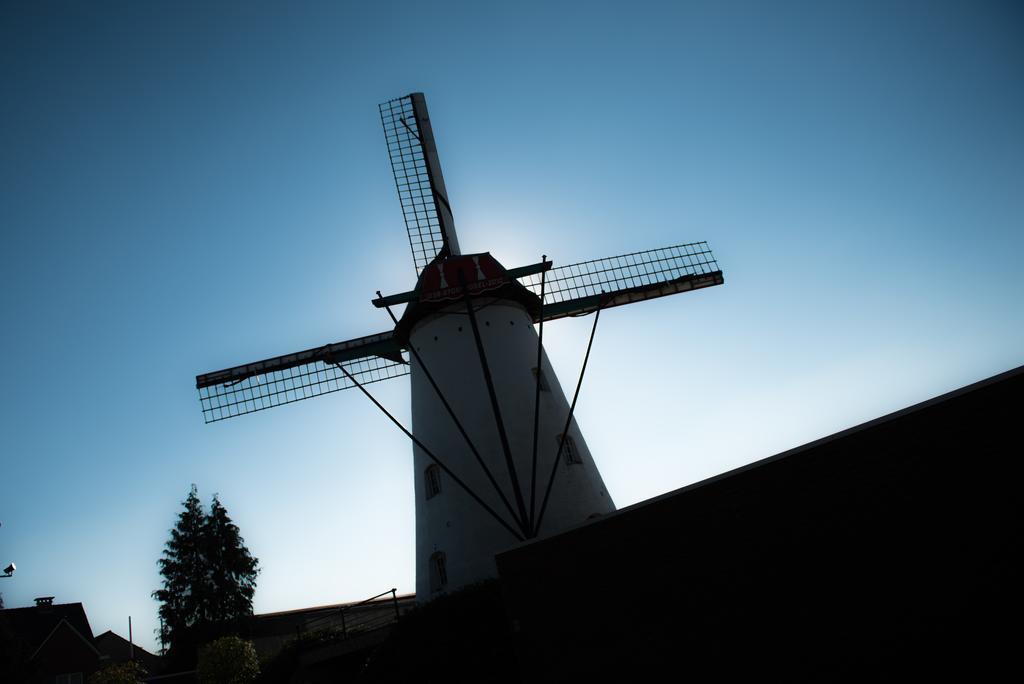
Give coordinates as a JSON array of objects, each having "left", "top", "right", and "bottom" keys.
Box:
[{"left": 380, "top": 92, "right": 459, "bottom": 275}]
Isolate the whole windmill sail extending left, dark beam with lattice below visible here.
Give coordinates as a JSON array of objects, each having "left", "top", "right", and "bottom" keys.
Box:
[{"left": 196, "top": 332, "right": 409, "bottom": 423}]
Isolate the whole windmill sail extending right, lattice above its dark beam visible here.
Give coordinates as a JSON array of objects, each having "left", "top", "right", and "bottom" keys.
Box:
[{"left": 519, "top": 242, "right": 725, "bottom": 320}]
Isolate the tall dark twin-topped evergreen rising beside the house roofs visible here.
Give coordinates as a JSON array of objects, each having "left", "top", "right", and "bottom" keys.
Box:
[{"left": 153, "top": 484, "right": 259, "bottom": 668}]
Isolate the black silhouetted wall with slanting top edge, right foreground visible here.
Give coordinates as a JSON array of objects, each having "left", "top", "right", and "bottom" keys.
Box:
[{"left": 498, "top": 368, "right": 1024, "bottom": 681}]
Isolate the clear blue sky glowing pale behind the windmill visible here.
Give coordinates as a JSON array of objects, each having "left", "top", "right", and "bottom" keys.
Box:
[{"left": 0, "top": 0, "right": 1024, "bottom": 648}]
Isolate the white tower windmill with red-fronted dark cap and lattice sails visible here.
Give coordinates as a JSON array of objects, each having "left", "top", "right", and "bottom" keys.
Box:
[{"left": 196, "top": 93, "right": 724, "bottom": 601}]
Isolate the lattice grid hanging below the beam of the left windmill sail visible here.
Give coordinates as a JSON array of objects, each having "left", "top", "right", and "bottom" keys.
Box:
[{"left": 199, "top": 356, "right": 409, "bottom": 423}]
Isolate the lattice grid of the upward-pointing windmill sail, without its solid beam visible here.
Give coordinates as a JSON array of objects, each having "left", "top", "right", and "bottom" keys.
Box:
[{"left": 380, "top": 95, "right": 444, "bottom": 275}]
